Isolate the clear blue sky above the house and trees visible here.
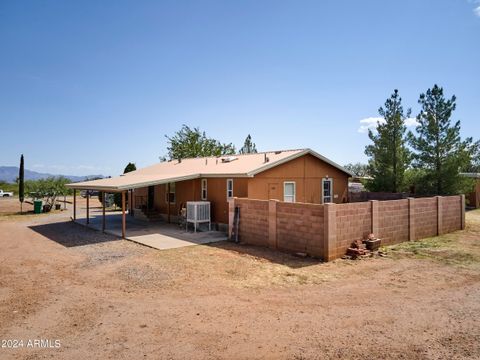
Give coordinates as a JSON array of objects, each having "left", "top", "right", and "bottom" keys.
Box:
[{"left": 0, "top": 0, "right": 480, "bottom": 175}]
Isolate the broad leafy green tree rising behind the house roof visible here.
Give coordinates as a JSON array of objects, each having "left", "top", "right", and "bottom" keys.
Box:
[{"left": 165, "top": 125, "right": 235, "bottom": 160}]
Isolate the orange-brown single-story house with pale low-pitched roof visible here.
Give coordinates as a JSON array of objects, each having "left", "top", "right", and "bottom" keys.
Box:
[{"left": 67, "top": 149, "right": 352, "bottom": 233}]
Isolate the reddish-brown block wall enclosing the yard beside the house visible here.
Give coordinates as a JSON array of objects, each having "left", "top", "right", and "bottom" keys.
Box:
[{"left": 229, "top": 195, "right": 465, "bottom": 261}]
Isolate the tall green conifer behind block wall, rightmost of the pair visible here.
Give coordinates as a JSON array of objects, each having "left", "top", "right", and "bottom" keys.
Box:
[{"left": 409, "top": 85, "right": 474, "bottom": 195}]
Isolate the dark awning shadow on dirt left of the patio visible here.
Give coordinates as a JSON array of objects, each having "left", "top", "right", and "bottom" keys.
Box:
[{"left": 29, "top": 221, "right": 121, "bottom": 247}]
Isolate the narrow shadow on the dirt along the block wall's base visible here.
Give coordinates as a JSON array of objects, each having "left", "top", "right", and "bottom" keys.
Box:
[{"left": 205, "top": 241, "right": 322, "bottom": 269}]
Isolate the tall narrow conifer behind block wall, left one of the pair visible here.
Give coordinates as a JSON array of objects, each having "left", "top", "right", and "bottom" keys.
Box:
[{"left": 365, "top": 89, "right": 411, "bottom": 192}]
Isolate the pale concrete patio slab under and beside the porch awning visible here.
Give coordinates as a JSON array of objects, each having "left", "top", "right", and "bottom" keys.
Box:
[{"left": 75, "top": 210, "right": 227, "bottom": 250}]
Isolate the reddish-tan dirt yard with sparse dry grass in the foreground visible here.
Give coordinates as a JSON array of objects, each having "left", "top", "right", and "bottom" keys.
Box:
[{"left": 0, "top": 197, "right": 480, "bottom": 359}]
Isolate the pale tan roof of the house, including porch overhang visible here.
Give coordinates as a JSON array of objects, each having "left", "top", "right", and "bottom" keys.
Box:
[{"left": 67, "top": 149, "right": 353, "bottom": 191}]
